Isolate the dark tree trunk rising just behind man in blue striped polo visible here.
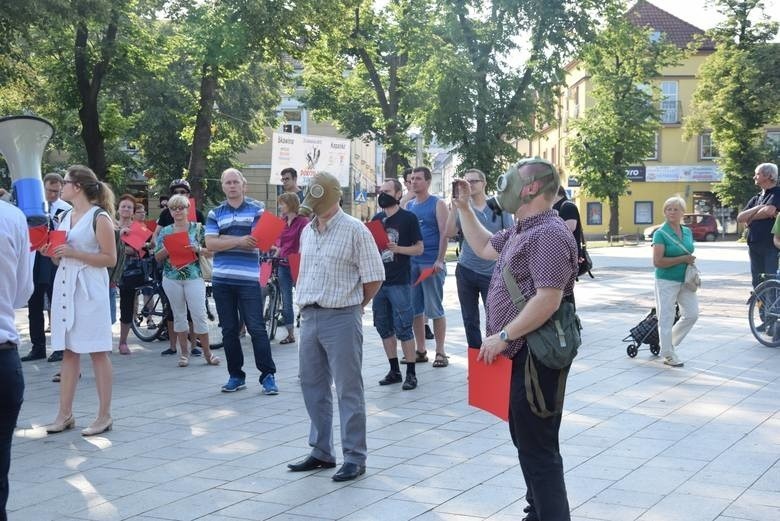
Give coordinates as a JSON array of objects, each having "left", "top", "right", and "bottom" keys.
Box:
[{"left": 187, "top": 63, "right": 217, "bottom": 208}]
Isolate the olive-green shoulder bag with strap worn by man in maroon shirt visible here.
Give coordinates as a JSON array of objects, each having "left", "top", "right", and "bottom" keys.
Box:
[{"left": 501, "top": 263, "right": 582, "bottom": 418}]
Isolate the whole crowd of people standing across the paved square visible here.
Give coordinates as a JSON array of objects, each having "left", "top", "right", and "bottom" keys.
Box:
[{"left": 0, "top": 159, "right": 780, "bottom": 521}]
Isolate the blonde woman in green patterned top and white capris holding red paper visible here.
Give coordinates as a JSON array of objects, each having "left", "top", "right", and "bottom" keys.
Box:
[{"left": 154, "top": 195, "right": 219, "bottom": 367}]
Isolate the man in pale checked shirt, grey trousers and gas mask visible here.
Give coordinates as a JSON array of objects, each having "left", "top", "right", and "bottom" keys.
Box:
[{"left": 288, "top": 172, "right": 385, "bottom": 481}]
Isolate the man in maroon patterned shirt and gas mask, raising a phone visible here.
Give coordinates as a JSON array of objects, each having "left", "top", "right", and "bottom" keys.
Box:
[{"left": 453, "top": 158, "right": 577, "bottom": 521}]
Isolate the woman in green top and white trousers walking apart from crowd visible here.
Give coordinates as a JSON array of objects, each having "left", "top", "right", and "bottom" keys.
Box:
[{"left": 653, "top": 193, "right": 699, "bottom": 367}]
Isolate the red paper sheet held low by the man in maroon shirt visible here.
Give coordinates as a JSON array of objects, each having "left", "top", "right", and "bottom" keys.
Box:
[{"left": 466, "top": 348, "right": 512, "bottom": 421}]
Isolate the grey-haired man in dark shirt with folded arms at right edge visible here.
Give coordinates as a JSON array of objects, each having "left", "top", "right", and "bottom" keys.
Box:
[{"left": 737, "top": 163, "right": 780, "bottom": 288}]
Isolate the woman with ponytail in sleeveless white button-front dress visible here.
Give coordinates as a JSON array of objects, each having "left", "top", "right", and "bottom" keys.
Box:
[{"left": 46, "top": 165, "right": 116, "bottom": 436}]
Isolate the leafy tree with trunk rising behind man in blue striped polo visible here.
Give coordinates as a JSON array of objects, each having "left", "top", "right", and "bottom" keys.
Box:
[{"left": 170, "top": 0, "right": 348, "bottom": 206}]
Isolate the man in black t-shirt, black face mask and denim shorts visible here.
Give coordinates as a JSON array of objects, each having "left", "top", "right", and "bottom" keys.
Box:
[{"left": 372, "top": 179, "right": 423, "bottom": 391}]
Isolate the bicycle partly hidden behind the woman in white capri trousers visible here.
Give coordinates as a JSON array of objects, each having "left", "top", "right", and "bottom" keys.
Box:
[{"left": 130, "top": 259, "right": 223, "bottom": 349}]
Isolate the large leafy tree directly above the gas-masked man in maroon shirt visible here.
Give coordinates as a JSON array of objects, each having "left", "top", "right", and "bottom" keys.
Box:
[{"left": 425, "top": 0, "right": 612, "bottom": 183}]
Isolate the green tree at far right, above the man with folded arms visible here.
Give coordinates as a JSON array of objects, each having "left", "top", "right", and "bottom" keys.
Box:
[{"left": 684, "top": 0, "right": 780, "bottom": 206}]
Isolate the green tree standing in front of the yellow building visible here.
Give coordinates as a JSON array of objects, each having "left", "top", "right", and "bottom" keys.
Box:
[{"left": 568, "top": 12, "right": 683, "bottom": 235}]
